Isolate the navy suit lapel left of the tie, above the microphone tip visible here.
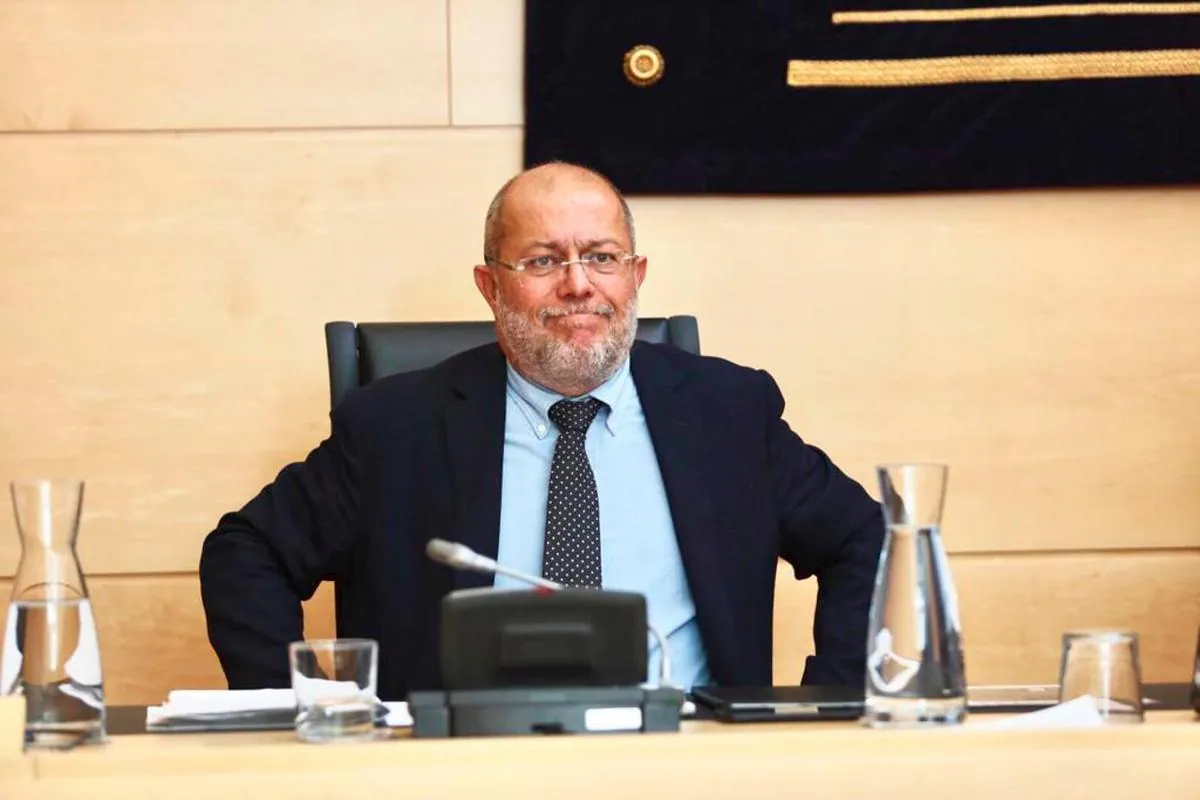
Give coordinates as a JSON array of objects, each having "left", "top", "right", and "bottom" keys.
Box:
[{"left": 445, "top": 347, "right": 505, "bottom": 589}]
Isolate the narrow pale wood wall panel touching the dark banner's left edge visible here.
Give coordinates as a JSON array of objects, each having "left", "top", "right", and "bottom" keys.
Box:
[{"left": 449, "top": 0, "right": 518, "bottom": 125}]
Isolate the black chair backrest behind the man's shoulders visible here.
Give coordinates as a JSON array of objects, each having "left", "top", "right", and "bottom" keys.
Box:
[{"left": 325, "top": 315, "right": 700, "bottom": 408}]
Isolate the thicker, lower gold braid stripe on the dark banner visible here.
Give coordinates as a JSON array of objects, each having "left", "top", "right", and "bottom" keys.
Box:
[{"left": 787, "top": 50, "right": 1200, "bottom": 86}]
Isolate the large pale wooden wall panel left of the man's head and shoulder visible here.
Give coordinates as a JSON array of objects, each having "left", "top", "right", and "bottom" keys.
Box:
[{"left": 0, "top": 130, "right": 520, "bottom": 575}]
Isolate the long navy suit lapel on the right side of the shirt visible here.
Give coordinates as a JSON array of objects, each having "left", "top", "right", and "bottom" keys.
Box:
[{"left": 630, "top": 343, "right": 737, "bottom": 676}]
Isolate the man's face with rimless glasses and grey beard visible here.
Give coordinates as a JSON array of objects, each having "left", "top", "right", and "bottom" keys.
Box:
[{"left": 475, "top": 176, "right": 646, "bottom": 393}]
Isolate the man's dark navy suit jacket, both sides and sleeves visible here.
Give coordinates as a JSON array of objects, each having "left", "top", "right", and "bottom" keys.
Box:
[{"left": 200, "top": 342, "right": 883, "bottom": 699}]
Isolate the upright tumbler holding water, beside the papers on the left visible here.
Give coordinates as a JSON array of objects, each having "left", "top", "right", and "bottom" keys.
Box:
[{"left": 288, "top": 639, "right": 379, "bottom": 742}]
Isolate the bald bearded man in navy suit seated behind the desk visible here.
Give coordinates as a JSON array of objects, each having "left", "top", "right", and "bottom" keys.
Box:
[{"left": 200, "top": 163, "right": 883, "bottom": 698}]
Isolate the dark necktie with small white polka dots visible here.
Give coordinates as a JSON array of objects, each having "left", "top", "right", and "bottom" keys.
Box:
[{"left": 541, "top": 397, "right": 604, "bottom": 589}]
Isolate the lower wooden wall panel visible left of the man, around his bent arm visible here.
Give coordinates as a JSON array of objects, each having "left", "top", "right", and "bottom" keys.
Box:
[{"left": 0, "top": 575, "right": 334, "bottom": 705}]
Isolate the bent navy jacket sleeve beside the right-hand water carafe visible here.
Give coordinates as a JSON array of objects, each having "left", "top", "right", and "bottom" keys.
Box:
[{"left": 760, "top": 373, "right": 883, "bottom": 687}]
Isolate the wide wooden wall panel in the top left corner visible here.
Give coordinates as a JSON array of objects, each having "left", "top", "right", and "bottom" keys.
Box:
[{"left": 0, "top": 0, "right": 449, "bottom": 131}]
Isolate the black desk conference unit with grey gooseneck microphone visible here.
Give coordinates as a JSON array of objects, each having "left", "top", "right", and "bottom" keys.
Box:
[{"left": 408, "top": 540, "right": 684, "bottom": 739}]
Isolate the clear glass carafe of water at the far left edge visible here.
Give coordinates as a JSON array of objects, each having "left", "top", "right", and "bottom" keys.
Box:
[{"left": 0, "top": 480, "right": 106, "bottom": 748}]
